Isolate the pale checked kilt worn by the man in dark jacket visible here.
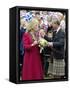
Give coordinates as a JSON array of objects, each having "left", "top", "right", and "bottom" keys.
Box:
[{"left": 53, "top": 59, "right": 65, "bottom": 76}]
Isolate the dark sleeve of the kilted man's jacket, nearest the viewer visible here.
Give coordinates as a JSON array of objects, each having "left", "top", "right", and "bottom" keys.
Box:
[{"left": 53, "top": 33, "right": 65, "bottom": 48}]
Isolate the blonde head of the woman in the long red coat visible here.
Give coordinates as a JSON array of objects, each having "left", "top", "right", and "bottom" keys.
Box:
[{"left": 27, "top": 18, "right": 39, "bottom": 32}]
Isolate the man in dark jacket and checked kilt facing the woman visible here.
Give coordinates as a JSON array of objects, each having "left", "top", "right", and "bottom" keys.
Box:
[{"left": 41, "top": 20, "right": 65, "bottom": 77}]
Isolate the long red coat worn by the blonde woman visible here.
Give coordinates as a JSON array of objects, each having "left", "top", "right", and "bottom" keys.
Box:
[{"left": 22, "top": 33, "right": 43, "bottom": 80}]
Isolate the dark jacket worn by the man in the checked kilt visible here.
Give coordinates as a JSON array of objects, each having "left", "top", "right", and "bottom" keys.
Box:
[{"left": 44, "top": 29, "right": 65, "bottom": 59}]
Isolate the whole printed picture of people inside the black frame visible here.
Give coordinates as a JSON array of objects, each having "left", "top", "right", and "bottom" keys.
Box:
[{"left": 20, "top": 10, "right": 66, "bottom": 80}]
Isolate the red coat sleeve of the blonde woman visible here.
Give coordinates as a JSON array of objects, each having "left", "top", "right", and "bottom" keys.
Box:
[{"left": 22, "top": 33, "right": 31, "bottom": 50}]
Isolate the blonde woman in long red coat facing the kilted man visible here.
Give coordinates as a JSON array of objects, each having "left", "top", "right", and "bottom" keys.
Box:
[{"left": 22, "top": 19, "right": 43, "bottom": 80}]
